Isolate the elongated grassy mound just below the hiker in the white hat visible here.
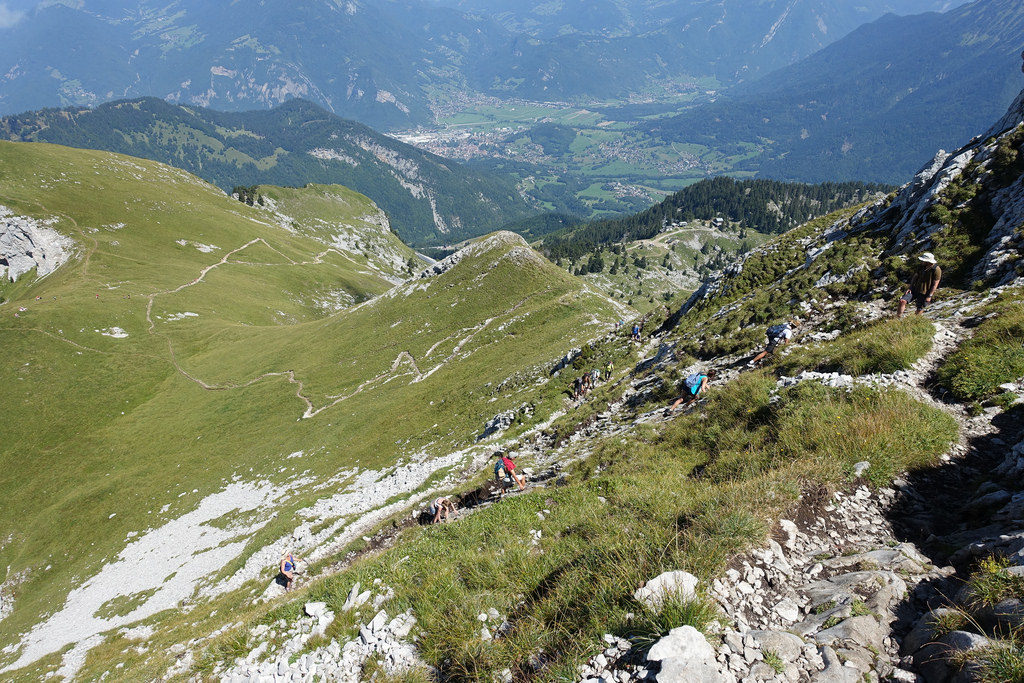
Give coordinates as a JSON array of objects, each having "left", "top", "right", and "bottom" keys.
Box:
[{"left": 775, "top": 315, "right": 935, "bottom": 376}]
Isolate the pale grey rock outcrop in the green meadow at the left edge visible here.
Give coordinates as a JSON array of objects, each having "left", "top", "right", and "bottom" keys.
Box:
[{"left": 0, "top": 206, "right": 75, "bottom": 283}]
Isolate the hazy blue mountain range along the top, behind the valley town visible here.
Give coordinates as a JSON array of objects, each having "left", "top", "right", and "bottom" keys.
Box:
[{"left": 0, "top": 0, "right": 966, "bottom": 128}]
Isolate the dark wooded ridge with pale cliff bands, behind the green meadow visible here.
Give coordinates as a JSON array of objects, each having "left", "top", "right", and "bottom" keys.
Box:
[{"left": 0, "top": 97, "right": 534, "bottom": 244}]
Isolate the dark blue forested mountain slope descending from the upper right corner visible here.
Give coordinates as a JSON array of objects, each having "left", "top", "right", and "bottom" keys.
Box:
[{"left": 649, "top": 0, "right": 1024, "bottom": 182}]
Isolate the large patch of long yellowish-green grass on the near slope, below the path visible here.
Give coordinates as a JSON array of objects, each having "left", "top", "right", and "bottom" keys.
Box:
[{"left": 172, "top": 372, "right": 956, "bottom": 681}]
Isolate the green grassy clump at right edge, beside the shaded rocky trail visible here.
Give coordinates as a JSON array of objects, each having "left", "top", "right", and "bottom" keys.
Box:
[{"left": 938, "top": 289, "right": 1024, "bottom": 401}]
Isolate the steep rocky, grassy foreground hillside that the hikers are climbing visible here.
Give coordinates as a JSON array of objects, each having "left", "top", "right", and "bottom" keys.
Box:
[{"left": 112, "top": 74, "right": 1024, "bottom": 682}]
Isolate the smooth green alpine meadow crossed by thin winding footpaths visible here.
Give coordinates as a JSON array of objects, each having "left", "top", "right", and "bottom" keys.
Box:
[{"left": 0, "top": 142, "right": 629, "bottom": 679}]
